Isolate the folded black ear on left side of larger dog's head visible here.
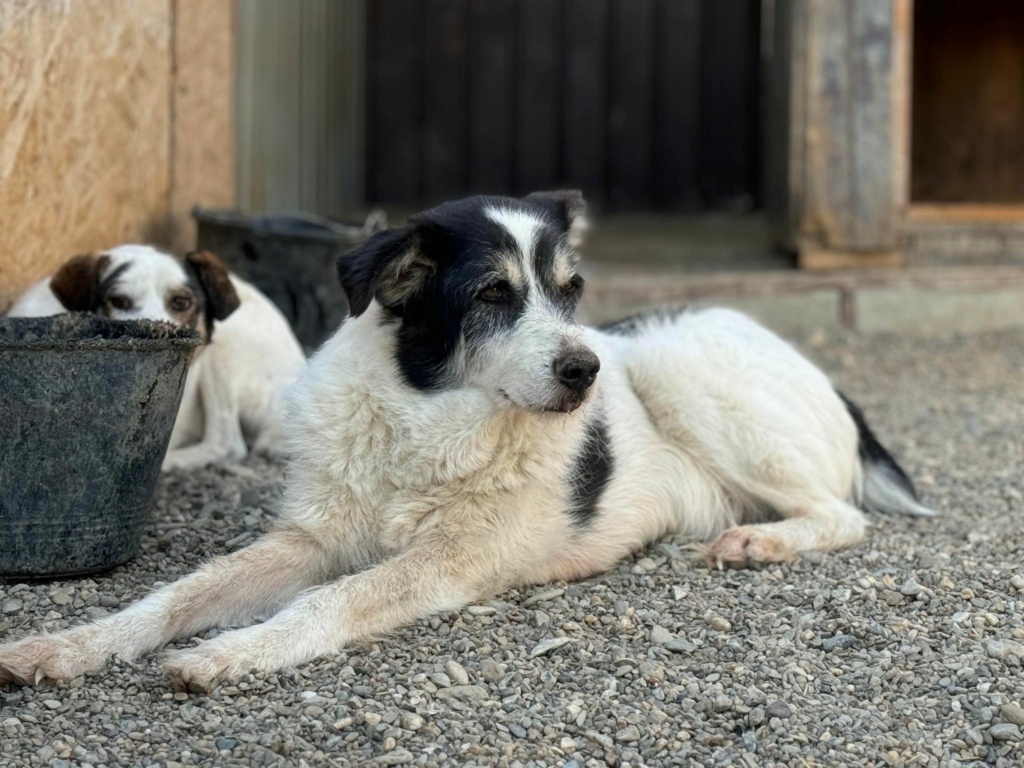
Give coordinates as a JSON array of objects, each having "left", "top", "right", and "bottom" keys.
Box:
[{"left": 338, "top": 225, "right": 436, "bottom": 317}]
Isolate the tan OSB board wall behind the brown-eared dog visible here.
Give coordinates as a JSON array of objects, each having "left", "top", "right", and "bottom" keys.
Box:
[{"left": 0, "top": 0, "right": 233, "bottom": 310}]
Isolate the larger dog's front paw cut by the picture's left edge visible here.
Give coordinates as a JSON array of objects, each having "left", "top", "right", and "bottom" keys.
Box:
[{"left": 0, "top": 635, "right": 106, "bottom": 685}]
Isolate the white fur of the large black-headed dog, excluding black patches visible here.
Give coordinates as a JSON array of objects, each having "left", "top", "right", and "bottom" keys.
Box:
[{"left": 0, "top": 215, "right": 929, "bottom": 688}]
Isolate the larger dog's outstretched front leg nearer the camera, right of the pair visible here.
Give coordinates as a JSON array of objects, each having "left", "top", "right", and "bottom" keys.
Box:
[{"left": 164, "top": 540, "right": 487, "bottom": 690}]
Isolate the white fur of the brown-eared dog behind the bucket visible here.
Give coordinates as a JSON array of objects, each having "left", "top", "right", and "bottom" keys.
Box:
[{"left": 8, "top": 245, "right": 304, "bottom": 469}]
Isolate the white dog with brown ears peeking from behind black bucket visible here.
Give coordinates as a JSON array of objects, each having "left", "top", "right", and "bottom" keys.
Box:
[{"left": 7, "top": 245, "right": 305, "bottom": 469}]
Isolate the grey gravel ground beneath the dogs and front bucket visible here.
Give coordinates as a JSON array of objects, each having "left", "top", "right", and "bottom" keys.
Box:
[{"left": 0, "top": 335, "right": 1024, "bottom": 768}]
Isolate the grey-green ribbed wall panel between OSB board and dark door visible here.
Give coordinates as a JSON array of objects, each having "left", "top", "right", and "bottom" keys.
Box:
[{"left": 236, "top": 0, "right": 366, "bottom": 217}]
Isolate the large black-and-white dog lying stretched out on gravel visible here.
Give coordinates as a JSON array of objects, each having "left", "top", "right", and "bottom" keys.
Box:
[{"left": 0, "top": 191, "right": 931, "bottom": 689}]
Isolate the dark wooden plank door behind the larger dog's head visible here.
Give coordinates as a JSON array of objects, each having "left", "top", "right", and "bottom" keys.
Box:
[{"left": 367, "top": 0, "right": 761, "bottom": 211}]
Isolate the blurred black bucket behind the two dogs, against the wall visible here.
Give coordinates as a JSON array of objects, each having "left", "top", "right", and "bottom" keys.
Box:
[{"left": 193, "top": 208, "right": 387, "bottom": 352}]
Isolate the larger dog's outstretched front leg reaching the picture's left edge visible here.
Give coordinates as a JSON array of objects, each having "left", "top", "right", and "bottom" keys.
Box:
[{"left": 0, "top": 527, "right": 331, "bottom": 684}]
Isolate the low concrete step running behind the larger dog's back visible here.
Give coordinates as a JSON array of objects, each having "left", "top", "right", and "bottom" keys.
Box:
[{"left": 581, "top": 262, "right": 1024, "bottom": 336}]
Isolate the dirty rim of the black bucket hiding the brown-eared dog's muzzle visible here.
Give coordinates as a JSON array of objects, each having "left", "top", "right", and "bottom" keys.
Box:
[{"left": 0, "top": 312, "right": 203, "bottom": 352}]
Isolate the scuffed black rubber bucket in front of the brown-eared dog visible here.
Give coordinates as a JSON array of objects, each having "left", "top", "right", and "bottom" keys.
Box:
[{"left": 0, "top": 313, "right": 200, "bottom": 579}]
